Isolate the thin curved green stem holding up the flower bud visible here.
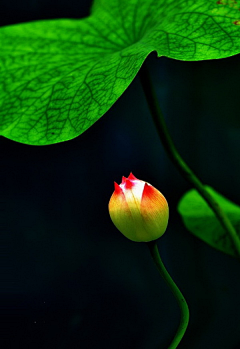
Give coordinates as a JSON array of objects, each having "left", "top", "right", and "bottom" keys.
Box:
[{"left": 146, "top": 241, "right": 189, "bottom": 349}]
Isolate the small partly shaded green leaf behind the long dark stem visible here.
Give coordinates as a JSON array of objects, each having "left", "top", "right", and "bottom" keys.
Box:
[{"left": 178, "top": 186, "right": 240, "bottom": 257}]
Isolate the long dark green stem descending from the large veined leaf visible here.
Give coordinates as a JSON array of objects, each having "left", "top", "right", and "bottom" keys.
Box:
[{"left": 139, "top": 63, "right": 240, "bottom": 257}]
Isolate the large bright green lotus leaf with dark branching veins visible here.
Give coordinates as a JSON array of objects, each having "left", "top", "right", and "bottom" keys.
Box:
[{"left": 0, "top": 0, "right": 240, "bottom": 145}]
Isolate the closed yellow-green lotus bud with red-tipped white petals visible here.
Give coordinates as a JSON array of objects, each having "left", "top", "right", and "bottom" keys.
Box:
[{"left": 108, "top": 173, "right": 169, "bottom": 242}]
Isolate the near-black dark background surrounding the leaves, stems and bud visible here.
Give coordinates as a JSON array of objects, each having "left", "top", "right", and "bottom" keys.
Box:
[{"left": 0, "top": 0, "right": 240, "bottom": 349}]
